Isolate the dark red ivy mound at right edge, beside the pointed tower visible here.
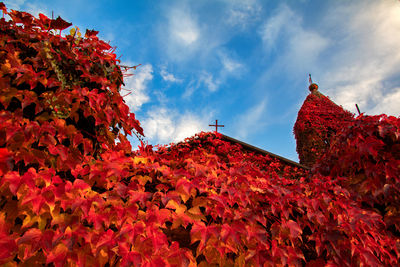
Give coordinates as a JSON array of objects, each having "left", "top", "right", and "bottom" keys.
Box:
[{"left": 315, "top": 115, "right": 400, "bottom": 236}]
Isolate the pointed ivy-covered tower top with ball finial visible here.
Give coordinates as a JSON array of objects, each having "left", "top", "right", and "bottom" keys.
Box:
[{"left": 293, "top": 83, "right": 354, "bottom": 167}]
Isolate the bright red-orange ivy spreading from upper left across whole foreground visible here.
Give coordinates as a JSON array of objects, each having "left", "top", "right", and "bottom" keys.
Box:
[{"left": 0, "top": 3, "right": 399, "bottom": 266}]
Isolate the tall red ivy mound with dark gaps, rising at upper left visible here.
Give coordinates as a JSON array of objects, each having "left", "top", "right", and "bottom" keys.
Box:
[{"left": 0, "top": 4, "right": 143, "bottom": 170}]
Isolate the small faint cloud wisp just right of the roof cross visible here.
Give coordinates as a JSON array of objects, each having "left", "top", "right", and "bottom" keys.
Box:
[{"left": 236, "top": 100, "right": 267, "bottom": 139}]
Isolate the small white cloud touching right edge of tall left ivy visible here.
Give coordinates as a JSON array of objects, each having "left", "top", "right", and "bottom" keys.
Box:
[{"left": 121, "top": 64, "right": 153, "bottom": 112}]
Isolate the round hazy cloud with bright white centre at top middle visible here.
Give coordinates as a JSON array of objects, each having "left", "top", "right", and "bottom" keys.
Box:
[{"left": 158, "top": 1, "right": 242, "bottom": 64}]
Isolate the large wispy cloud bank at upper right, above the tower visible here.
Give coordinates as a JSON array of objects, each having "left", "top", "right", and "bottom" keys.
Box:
[{"left": 259, "top": 0, "right": 400, "bottom": 116}]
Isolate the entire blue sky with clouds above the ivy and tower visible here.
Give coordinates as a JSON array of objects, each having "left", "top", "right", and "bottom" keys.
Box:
[{"left": 4, "top": 0, "right": 400, "bottom": 161}]
